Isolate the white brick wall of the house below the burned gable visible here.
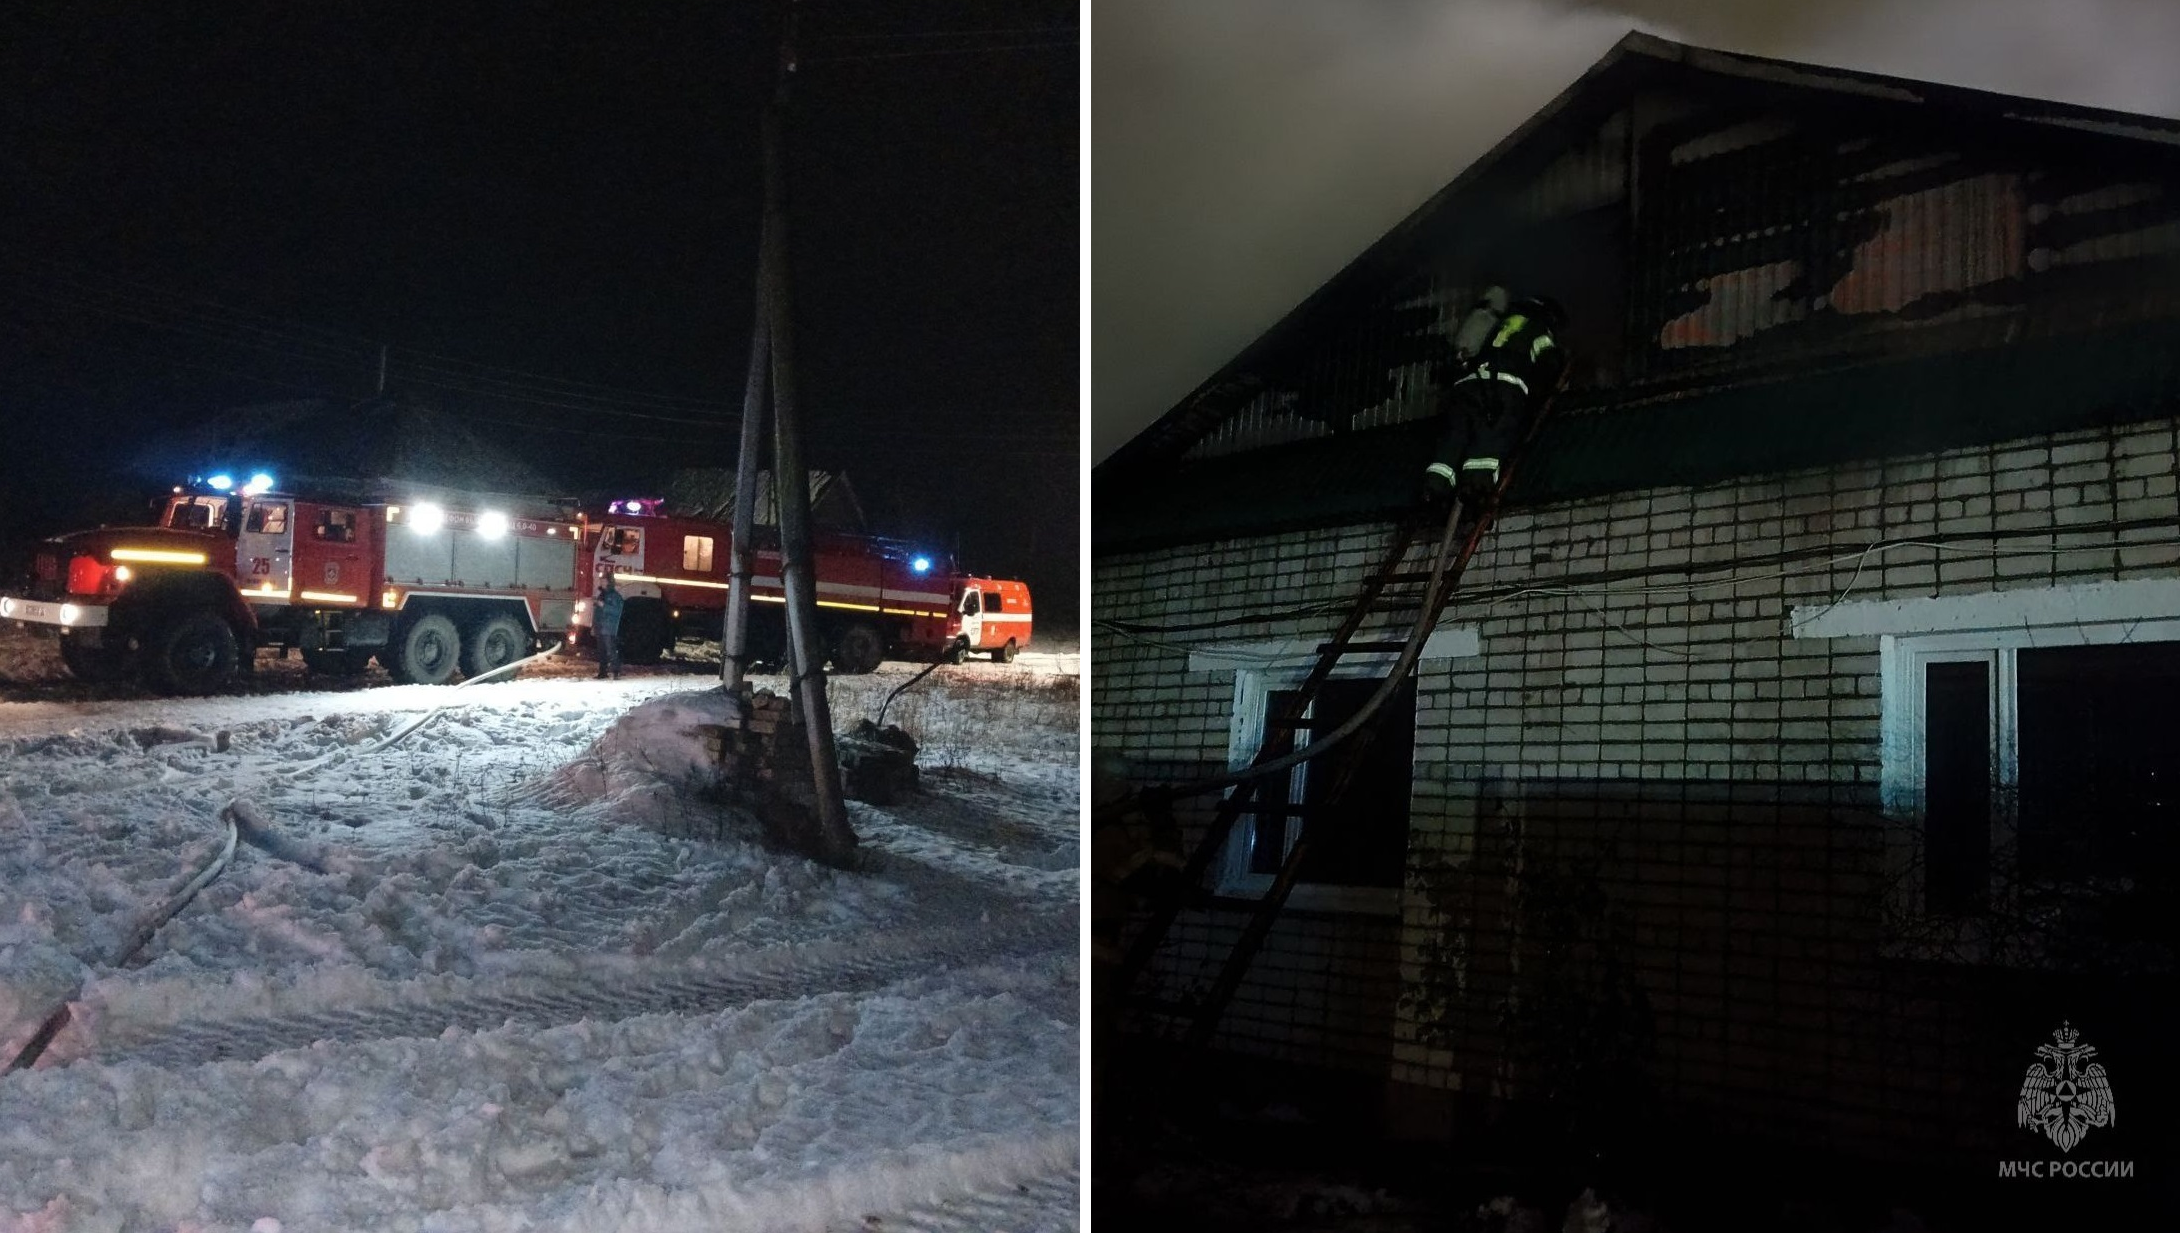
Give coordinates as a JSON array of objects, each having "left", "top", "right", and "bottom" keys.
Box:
[{"left": 1093, "top": 421, "right": 2177, "bottom": 1139}]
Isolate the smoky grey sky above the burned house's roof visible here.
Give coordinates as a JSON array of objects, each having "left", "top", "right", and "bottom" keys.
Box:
[{"left": 1091, "top": 0, "right": 2181, "bottom": 463}]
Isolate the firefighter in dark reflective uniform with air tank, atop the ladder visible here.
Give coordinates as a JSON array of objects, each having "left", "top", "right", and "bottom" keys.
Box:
[{"left": 1424, "top": 297, "right": 1566, "bottom": 513}]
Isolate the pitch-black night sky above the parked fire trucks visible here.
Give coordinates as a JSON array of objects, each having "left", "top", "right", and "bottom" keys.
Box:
[{"left": 0, "top": 0, "right": 1080, "bottom": 611}]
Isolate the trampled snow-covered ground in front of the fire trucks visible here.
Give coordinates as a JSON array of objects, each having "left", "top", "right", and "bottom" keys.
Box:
[{"left": 0, "top": 629, "right": 1080, "bottom": 1233}]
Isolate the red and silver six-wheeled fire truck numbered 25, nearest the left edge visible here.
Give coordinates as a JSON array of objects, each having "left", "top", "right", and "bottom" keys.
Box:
[{"left": 0, "top": 474, "right": 582, "bottom": 694}]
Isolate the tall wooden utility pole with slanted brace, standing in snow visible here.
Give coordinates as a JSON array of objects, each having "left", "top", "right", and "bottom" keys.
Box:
[{"left": 741, "top": 2, "right": 855, "bottom": 866}]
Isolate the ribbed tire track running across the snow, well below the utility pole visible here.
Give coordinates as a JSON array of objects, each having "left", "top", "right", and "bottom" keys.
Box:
[{"left": 74, "top": 919, "right": 1075, "bottom": 1069}]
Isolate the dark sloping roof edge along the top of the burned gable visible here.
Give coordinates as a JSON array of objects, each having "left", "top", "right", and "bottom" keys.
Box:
[{"left": 1093, "top": 33, "right": 2181, "bottom": 482}]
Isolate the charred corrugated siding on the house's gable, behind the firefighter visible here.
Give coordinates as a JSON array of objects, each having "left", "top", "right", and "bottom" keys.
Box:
[{"left": 1184, "top": 89, "right": 2181, "bottom": 458}]
